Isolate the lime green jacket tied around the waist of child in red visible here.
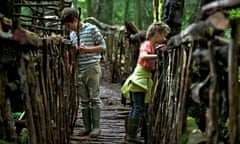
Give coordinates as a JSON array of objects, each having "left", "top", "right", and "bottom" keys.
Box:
[{"left": 121, "top": 64, "right": 153, "bottom": 103}]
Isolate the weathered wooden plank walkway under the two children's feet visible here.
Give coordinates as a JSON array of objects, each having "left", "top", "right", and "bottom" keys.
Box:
[{"left": 70, "top": 81, "right": 130, "bottom": 144}]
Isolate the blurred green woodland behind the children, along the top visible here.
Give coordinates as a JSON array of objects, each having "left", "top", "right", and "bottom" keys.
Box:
[{"left": 18, "top": 0, "right": 240, "bottom": 38}]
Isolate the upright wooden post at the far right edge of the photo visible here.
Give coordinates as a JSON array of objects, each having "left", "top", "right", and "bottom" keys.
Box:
[{"left": 228, "top": 19, "right": 240, "bottom": 144}]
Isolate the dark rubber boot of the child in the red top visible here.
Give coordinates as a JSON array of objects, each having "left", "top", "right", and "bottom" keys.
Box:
[{"left": 126, "top": 118, "right": 143, "bottom": 144}]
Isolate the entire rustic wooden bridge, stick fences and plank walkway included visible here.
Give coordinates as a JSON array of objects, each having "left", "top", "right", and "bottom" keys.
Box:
[{"left": 0, "top": 0, "right": 240, "bottom": 144}]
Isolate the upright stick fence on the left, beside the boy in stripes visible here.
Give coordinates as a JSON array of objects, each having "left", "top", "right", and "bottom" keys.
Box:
[{"left": 0, "top": 29, "right": 78, "bottom": 144}]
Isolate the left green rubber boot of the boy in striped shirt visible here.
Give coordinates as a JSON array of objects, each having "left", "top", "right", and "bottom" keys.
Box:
[{"left": 78, "top": 108, "right": 91, "bottom": 136}]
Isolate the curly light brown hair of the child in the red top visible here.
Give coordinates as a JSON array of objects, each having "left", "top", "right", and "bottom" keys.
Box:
[{"left": 146, "top": 22, "right": 170, "bottom": 40}]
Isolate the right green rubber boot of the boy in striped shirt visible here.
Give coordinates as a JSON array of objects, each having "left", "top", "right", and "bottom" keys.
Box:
[{"left": 90, "top": 107, "right": 101, "bottom": 137}]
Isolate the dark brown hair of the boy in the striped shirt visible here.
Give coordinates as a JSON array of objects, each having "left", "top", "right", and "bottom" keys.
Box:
[{"left": 61, "top": 7, "right": 78, "bottom": 23}]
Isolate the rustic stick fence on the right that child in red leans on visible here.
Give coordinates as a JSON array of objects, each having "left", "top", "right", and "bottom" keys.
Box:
[{"left": 148, "top": 1, "right": 240, "bottom": 144}]
